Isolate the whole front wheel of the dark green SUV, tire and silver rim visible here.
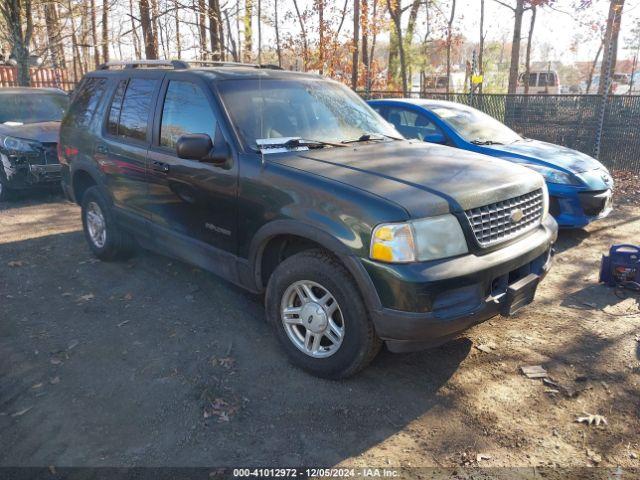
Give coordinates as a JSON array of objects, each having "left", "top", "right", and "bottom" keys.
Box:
[{"left": 265, "top": 250, "right": 382, "bottom": 379}]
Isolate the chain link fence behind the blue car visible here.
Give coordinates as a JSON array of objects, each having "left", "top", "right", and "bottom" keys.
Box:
[{"left": 359, "top": 91, "right": 640, "bottom": 173}]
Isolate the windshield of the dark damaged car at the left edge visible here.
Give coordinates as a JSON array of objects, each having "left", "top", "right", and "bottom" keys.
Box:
[{"left": 0, "top": 92, "right": 69, "bottom": 124}]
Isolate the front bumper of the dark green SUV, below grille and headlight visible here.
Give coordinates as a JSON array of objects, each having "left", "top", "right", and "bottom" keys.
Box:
[{"left": 365, "top": 216, "right": 558, "bottom": 352}]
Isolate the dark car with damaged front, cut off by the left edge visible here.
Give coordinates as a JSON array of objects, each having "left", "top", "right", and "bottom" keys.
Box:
[{"left": 0, "top": 87, "right": 69, "bottom": 201}]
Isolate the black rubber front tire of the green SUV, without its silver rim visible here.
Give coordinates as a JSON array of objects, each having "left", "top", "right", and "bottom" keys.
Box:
[{"left": 265, "top": 250, "right": 382, "bottom": 379}]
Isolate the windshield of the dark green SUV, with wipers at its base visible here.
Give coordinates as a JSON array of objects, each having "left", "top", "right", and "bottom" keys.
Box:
[{"left": 218, "top": 79, "right": 402, "bottom": 148}]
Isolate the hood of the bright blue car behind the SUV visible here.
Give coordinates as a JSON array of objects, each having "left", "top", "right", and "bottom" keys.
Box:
[{"left": 486, "top": 139, "right": 602, "bottom": 173}]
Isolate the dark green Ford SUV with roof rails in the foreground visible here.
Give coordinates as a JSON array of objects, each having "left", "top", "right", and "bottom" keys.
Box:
[{"left": 60, "top": 61, "right": 557, "bottom": 378}]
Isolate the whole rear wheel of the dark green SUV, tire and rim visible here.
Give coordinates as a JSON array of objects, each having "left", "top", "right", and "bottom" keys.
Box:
[{"left": 82, "top": 186, "right": 135, "bottom": 261}]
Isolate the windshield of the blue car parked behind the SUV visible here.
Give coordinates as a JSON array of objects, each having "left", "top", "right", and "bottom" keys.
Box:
[{"left": 431, "top": 105, "right": 522, "bottom": 144}]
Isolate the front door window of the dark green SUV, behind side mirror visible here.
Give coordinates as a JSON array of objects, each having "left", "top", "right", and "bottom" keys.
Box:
[{"left": 160, "top": 80, "right": 216, "bottom": 149}]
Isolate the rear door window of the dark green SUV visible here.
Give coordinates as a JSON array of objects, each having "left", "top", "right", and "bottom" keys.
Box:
[{"left": 107, "top": 78, "right": 158, "bottom": 141}]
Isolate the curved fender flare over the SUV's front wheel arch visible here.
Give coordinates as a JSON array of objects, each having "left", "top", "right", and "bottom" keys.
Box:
[{"left": 248, "top": 220, "right": 382, "bottom": 310}]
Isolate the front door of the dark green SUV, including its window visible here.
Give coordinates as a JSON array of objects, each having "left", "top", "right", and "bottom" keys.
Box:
[{"left": 147, "top": 73, "right": 238, "bottom": 253}]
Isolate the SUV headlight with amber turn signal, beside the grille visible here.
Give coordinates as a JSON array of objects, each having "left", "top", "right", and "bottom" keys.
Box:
[{"left": 370, "top": 214, "right": 469, "bottom": 263}]
